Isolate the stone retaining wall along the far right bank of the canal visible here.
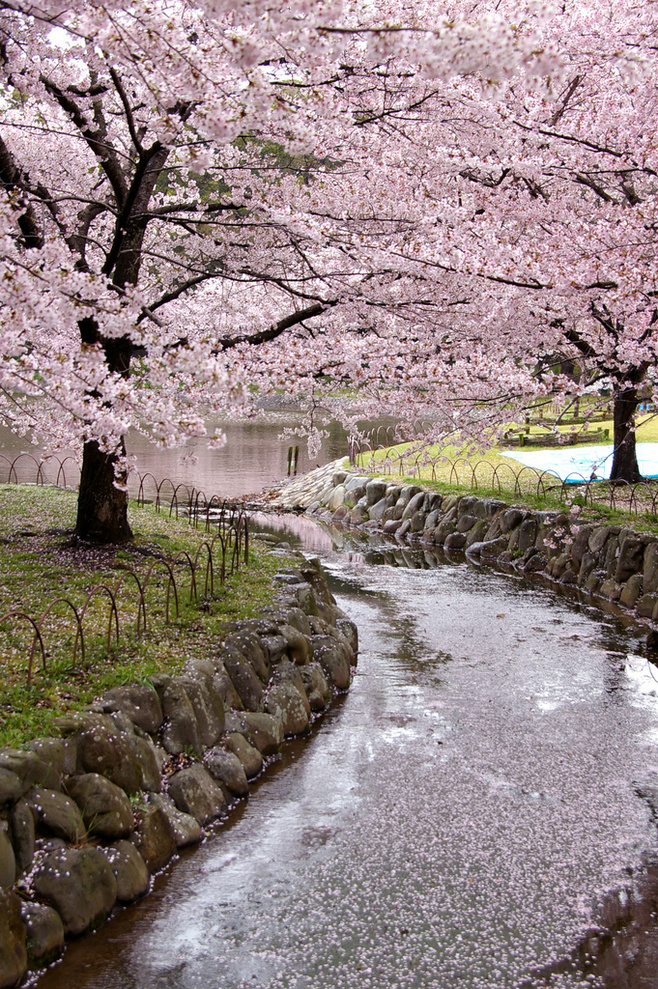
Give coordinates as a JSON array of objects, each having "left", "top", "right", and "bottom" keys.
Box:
[{"left": 270, "top": 461, "right": 658, "bottom": 621}]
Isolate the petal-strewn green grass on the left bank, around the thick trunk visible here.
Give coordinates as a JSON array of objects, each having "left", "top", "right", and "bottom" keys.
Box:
[{"left": 0, "top": 485, "right": 281, "bottom": 746}]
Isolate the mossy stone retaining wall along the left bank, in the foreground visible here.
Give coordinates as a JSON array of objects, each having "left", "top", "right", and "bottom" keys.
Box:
[{"left": 0, "top": 556, "right": 357, "bottom": 989}]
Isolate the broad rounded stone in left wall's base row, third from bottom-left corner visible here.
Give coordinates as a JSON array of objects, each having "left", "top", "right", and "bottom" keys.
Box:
[{"left": 32, "top": 846, "right": 117, "bottom": 936}]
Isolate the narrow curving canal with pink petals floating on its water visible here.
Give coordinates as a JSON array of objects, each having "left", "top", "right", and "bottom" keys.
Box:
[{"left": 32, "top": 529, "right": 658, "bottom": 989}]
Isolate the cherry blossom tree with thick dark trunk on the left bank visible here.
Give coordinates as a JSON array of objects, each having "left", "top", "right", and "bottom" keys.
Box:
[{"left": 0, "top": 0, "right": 552, "bottom": 540}]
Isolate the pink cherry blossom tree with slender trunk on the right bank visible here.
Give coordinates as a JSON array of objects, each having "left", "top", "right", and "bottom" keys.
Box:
[{"left": 258, "top": 2, "right": 657, "bottom": 481}]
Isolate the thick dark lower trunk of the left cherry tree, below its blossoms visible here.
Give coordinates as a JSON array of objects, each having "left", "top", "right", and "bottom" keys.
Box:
[{"left": 75, "top": 440, "right": 133, "bottom": 543}]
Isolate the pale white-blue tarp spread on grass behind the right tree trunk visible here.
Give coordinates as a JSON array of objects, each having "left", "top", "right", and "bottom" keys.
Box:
[{"left": 503, "top": 443, "right": 658, "bottom": 481}]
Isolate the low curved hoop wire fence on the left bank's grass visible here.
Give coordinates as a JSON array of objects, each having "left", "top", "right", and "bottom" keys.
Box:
[{"left": 0, "top": 454, "right": 249, "bottom": 687}]
